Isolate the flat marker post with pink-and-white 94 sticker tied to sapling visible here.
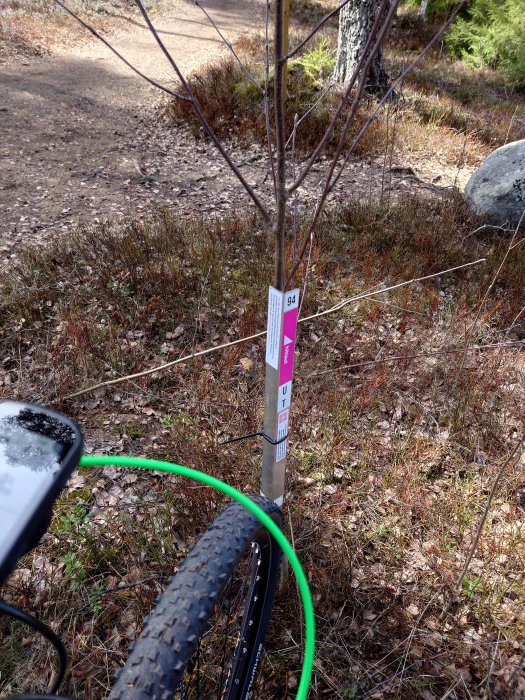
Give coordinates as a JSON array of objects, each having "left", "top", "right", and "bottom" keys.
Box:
[{"left": 261, "top": 287, "right": 299, "bottom": 505}]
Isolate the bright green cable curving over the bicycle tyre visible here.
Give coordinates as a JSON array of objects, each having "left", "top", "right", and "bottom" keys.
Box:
[{"left": 79, "top": 456, "right": 315, "bottom": 700}]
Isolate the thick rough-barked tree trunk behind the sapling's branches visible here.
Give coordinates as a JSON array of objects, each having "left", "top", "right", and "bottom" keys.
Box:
[{"left": 335, "top": 0, "right": 390, "bottom": 95}]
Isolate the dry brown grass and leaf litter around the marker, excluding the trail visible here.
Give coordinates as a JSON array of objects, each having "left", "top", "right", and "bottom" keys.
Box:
[{"left": 0, "top": 197, "right": 525, "bottom": 700}]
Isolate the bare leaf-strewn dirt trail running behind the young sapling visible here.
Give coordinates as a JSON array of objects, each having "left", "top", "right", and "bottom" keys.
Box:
[{"left": 0, "top": 0, "right": 474, "bottom": 260}]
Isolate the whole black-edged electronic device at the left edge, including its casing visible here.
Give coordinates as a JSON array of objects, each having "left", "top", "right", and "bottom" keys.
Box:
[{"left": 0, "top": 401, "right": 82, "bottom": 584}]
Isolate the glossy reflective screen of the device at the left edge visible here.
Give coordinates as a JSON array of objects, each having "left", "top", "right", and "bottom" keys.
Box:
[{"left": 0, "top": 401, "right": 78, "bottom": 576}]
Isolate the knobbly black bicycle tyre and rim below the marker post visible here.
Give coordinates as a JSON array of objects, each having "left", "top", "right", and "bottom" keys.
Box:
[{"left": 109, "top": 497, "right": 282, "bottom": 700}]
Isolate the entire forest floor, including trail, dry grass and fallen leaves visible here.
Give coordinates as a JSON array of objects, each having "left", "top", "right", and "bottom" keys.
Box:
[{"left": 0, "top": 0, "right": 525, "bottom": 700}]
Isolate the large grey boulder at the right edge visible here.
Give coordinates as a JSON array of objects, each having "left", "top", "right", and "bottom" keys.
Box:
[{"left": 465, "top": 139, "right": 525, "bottom": 225}]
